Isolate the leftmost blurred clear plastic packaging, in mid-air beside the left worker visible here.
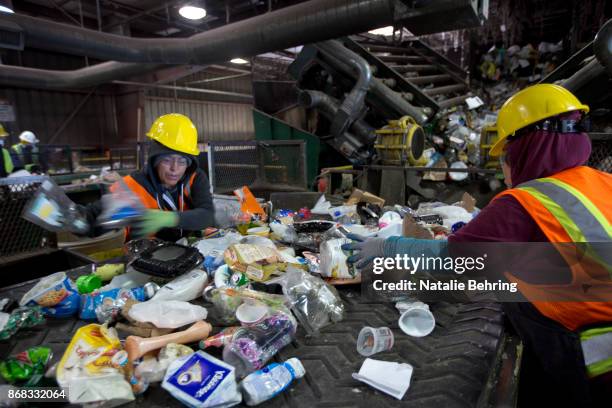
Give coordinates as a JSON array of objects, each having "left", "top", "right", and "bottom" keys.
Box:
[{"left": 23, "top": 179, "right": 90, "bottom": 234}]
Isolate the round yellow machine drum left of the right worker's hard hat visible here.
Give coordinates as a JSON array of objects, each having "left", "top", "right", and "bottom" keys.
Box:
[{"left": 374, "top": 116, "right": 425, "bottom": 166}]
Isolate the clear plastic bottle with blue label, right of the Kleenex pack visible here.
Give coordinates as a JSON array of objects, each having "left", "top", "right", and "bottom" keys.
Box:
[{"left": 240, "top": 358, "right": 306, "bottom": 406}]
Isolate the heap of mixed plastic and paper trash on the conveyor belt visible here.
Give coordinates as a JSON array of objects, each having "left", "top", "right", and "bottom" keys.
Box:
[{"left": 0, "top": 187, "right": 478, "bottom": 407}]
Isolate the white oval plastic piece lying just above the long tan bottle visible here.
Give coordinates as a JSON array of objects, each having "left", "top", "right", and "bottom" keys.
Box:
[{"left": 129, "top": 300, "right": 208, "bottom": 329}]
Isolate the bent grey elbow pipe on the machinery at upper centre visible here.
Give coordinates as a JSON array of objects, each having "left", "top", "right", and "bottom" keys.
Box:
[{"left": 316, "top": 40, "right": 372, "bottom": 136}]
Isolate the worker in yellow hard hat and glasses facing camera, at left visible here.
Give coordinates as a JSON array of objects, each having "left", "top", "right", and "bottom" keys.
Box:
[{"left": 87, "top": 113, "right": 215, "bottom": 241}]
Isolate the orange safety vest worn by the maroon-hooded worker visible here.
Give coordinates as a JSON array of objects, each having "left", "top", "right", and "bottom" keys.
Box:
[{"left": 495, "top": 166, "right": 612, "bottom": 331}]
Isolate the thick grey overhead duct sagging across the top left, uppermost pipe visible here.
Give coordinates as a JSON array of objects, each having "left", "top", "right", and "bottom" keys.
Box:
[{"left": 0, "top": 0, "right": 395, "bottom": 65}]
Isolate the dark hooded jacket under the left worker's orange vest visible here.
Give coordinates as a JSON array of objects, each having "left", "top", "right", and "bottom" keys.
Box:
[{"left": 86, "top": 142, "right": 215, "bottom": 241}]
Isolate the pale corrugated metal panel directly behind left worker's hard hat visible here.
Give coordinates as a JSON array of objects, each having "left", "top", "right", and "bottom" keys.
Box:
[{"left": 144, "top": 96, "right": 255, "bottom": 142}]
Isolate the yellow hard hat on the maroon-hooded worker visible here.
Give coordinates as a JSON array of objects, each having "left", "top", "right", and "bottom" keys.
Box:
[{"left": 490, "top": 84, "right": 589, "bottom": 156}]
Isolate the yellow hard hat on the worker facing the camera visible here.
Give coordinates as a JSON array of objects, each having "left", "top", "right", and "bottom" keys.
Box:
[{"left": 147, "top": 113, "right": 200, "bottom": 156}]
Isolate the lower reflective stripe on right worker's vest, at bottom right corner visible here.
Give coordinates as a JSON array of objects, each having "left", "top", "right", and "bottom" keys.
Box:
[{"left": 580, "top": 327, "right": 612, "bottom": 378}]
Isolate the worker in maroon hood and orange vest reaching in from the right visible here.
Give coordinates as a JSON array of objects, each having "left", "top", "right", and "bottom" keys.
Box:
[{"left": 345, "top": 84, "right": 612, "bottom": 407}]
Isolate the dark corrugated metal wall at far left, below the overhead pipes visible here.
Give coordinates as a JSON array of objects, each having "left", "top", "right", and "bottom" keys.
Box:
[{"left": 0, "top": 88, "right": 119, "bottom": 146}]
